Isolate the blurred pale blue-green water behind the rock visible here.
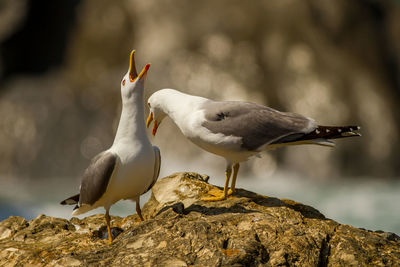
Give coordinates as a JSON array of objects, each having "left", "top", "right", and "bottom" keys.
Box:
[{"left": 0, "top": 159, "right": 400, "bottom": 234}]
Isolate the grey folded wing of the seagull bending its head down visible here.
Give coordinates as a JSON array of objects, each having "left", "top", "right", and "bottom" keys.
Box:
[{"left": 202, "top": 101, "right": 317, "bottom": 150}]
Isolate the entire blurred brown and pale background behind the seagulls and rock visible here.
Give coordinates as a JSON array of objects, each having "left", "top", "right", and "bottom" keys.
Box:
[{"left": 0, "top": 0, "right": 400, "bottom": 233}]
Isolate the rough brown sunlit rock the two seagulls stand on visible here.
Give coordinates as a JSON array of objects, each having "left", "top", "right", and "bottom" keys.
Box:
[{"left": 0, "top": 173, "right": 400, "bottom": 266}]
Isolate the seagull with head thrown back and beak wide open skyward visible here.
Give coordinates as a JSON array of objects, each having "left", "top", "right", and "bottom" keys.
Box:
[{"left": 60, "top": 50, "right": 161, "bottom": 244}]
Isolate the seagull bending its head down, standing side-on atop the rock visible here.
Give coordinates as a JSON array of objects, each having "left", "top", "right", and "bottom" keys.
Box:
[{"left": 146, "top": 89, "right": 360, "bottom": 201}]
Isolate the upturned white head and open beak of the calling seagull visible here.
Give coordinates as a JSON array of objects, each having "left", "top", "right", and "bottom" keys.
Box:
[{"left": 121, "top": 50, "right": 150, "bottom": 100}]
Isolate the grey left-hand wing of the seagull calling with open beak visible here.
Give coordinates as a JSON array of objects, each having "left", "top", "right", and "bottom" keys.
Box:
[{"left": 79, "top": 152, "right": 118, "bottom": 206}]
